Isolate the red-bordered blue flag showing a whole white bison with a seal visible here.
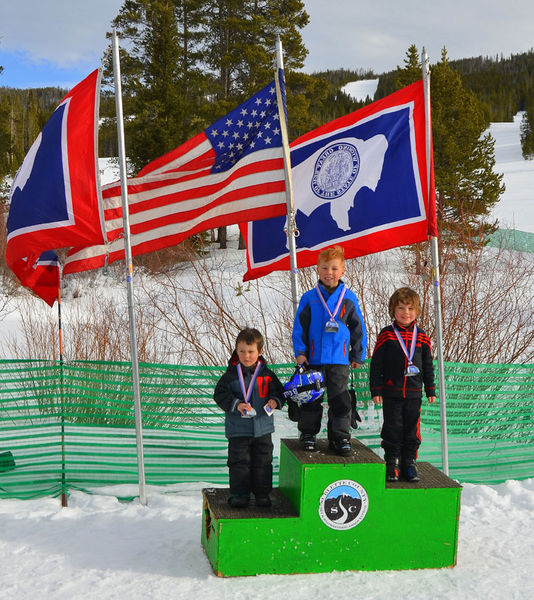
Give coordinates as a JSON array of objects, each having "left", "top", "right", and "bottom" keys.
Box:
[{"left": 240, "top": 81, "right": 436, "bottom": 281}]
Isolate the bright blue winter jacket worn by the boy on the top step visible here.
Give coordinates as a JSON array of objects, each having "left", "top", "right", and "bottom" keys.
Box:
[{"left": 293, "top": 281, "right": 367, "bottom": 365}]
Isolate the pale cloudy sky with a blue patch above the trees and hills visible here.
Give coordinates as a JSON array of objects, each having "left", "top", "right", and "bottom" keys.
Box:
[{"left": 0, "top": 0, "right": 534, "bottom": 88}]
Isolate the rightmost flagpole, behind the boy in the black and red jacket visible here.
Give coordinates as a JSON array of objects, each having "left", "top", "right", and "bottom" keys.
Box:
[{"left": 421, "top": 48, "right": 449, "bottom": 475}]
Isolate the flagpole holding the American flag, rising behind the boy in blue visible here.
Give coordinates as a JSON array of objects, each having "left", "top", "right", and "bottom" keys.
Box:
[{"left": 274, "top": 36, "right": 298, "bottom": 316}]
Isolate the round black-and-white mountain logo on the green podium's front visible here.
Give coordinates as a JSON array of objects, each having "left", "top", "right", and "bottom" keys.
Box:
[{"left": 319, "top": 479, "right": 369, "bottom": 529}]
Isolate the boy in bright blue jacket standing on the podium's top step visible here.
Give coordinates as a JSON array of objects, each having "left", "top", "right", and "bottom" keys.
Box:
[{"left": 293, "top": 246, "right": 367, "bottom": 456}]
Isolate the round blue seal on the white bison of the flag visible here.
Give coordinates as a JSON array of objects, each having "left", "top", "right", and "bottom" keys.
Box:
[{"left": 311, "top": 142, "right": 360, "bottom": 200}]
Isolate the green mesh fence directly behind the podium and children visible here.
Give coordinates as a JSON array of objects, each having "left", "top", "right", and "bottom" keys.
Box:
[{"left": 0, "top": 361, "right": 534, "bottom": 498}]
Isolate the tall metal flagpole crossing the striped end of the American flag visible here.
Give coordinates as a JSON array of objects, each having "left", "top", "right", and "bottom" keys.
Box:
[{"left": 113, "top": 29, "right": 147, "bottom": 506}]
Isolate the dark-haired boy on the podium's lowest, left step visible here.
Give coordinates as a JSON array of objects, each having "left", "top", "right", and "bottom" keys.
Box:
[{"left": 214, "top": 328, "right": 284, "bottom": 508}]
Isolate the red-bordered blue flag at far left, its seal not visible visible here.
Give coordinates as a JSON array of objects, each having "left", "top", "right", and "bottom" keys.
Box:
[{"left": 6, "top": 69, "right": 104, "bottom": 303}]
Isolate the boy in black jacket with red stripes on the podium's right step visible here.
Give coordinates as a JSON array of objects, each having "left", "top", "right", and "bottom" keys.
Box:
[{"left": 370, "top": 287, "right": 436, "bottom": 481}]
